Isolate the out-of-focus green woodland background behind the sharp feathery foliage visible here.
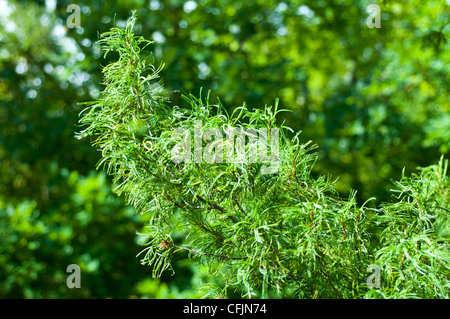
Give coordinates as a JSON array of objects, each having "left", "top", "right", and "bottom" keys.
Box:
[{"left": 0, "top": 0, "right": 450, "bottom": 298}]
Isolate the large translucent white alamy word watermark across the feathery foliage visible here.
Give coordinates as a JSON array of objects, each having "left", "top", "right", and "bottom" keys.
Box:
[{"left": 171, "top": 120, "right": 280, "bottom": 174}]
